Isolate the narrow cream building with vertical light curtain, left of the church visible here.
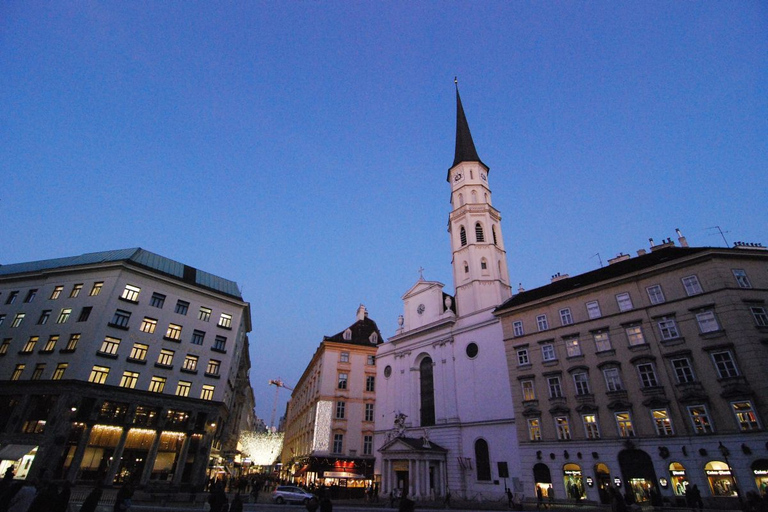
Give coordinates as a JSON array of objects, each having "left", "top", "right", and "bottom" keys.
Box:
[{"left": 282, "top": 305, "right": 382, "bottom": 497}]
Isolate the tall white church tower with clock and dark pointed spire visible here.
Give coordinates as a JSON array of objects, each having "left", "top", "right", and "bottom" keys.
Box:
[{"left": 448, "top": 85, "right": 512, "bottom": 317}]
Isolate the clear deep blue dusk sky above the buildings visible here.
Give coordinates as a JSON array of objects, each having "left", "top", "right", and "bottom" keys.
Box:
[{"left": 0, "top": 0, "right": 768, "bottom": 421}]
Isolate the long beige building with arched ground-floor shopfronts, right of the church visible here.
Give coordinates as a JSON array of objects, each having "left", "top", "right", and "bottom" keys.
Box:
[{"left": 496, "top": 237, "right": 768, "bottom": 508}]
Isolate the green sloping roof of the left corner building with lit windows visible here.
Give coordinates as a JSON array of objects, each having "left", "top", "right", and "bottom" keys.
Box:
[{"left": 0, "top": 247, "right": 242, "bottom": 299}]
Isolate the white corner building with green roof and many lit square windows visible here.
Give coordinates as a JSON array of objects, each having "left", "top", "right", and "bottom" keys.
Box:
[{"left": 0, "top": 249, "right": 253, "bottom": 487}]
